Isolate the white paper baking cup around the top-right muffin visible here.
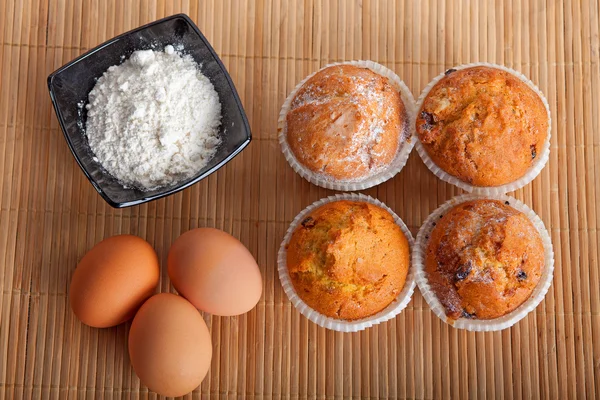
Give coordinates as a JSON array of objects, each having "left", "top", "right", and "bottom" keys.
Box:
[{"left": 413, "top": 62, "right": 552, "bottom": 195}]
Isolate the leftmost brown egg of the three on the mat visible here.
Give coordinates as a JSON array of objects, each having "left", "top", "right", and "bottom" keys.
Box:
[{"left": 69, "top": 235, "right": 160, "bottom": 328}]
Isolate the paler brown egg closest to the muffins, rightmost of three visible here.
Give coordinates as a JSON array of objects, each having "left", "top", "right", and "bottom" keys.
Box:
[{"left": 168, "top": 228, "right": 262, "bottom": 316}]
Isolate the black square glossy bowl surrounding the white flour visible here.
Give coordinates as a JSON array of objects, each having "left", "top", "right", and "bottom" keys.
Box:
[{"left": 48, "top": 14, "right": 251, "bottom": 208}]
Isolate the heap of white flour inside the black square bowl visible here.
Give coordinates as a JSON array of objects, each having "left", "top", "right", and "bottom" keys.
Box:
[{"left": 86, "top": 45, "right": 221, "bottom": 190}]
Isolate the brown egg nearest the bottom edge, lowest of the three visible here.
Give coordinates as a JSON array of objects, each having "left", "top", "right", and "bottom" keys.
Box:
[{"left": 129, "top": 293, "right": 212, "bottom": 397}]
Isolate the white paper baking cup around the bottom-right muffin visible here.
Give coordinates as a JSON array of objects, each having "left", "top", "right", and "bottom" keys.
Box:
[{"left": 412, "top": 194, "right": 554, "bottom": 331}]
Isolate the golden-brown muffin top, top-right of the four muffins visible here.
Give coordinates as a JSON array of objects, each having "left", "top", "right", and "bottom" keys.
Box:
[{"left": 416, "top": 67, "right": 549, "bottom": 186}]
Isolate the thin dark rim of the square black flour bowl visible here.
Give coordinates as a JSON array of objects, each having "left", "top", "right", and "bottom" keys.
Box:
[{"left": 47, "top": 13, "right": 252, "bottom": 208}]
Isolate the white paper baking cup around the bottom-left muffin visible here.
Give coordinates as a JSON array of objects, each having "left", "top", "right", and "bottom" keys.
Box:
[{"left": 277, "top": 193, "right": 416, "bottom": 332}]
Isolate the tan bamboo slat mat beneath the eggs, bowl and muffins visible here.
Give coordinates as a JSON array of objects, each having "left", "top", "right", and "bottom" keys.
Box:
[{"left": 0, "top": 0, "right": 600, "bottom": 399}]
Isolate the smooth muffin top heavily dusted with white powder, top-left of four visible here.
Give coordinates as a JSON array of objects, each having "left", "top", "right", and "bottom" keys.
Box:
[{"left": 286, "top": 65, "right": 408, "bottom": 181}]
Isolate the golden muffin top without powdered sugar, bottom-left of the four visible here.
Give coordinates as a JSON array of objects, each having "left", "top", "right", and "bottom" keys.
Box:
[{"left": 287, "top": 200, "right": 410, "bottom": 321}]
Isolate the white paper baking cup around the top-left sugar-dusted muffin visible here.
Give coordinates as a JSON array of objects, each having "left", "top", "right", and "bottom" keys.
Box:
[{"left": 277, "top": 60, "right": 417, "bottom": 191}]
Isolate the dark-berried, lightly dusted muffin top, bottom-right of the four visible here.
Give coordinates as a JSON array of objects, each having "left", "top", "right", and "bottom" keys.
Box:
[{"left": 425, "top": 200, "right": 545, "bottom": 319}]
